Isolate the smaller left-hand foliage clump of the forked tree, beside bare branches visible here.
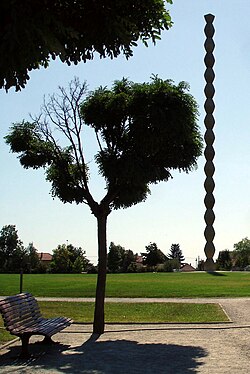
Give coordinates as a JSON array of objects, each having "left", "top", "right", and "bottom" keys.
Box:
[{"left": 5, "top": 121, "right": 87, "bottom": 203}]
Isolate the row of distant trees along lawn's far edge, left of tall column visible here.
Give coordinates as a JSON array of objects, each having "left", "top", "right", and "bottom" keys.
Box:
[{"left": 0, "top": 225, "right": 188, "bottom": 273}]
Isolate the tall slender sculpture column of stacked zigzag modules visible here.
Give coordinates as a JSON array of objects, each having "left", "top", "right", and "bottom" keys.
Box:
[{"left": 204, "top": 14, "right": 215, "bottom": 271}]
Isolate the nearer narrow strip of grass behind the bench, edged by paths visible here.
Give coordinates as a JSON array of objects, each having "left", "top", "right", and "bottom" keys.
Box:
[{"left": 0, "top": 301, "right": 228, "bottom": 344}]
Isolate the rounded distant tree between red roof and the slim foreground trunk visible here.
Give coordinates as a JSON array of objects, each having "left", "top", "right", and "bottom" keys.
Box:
[{"left": 50, "top": 244, "right": 90, "bottom": 273}]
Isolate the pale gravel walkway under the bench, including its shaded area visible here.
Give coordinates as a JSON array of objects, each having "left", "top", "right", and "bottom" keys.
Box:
[{"left": 0, "top": 298, "right": 250, "bottom": 374}]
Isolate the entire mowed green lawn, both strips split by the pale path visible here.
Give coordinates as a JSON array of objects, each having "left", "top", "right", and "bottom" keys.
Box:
[{"left": 0, "top": 272, "right": 246, "bottom": 344}]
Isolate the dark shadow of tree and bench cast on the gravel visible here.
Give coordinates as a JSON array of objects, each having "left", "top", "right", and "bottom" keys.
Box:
[{"left": 0, "top": 335, "right": 208, "bottom": 374}]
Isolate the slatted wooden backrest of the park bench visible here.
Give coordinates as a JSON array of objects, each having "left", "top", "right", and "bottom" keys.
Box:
[{"left": 0, "top": 293, "right": 41, "bottom": 331}]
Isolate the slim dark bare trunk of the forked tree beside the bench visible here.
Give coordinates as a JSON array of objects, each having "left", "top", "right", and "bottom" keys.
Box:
[{"left": 93, "top": 212, "right": 108, "bottom": 334}]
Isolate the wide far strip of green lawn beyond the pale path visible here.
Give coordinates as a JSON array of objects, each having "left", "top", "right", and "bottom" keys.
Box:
[{"left": 0, "top": 272, "right": 250, "bottom": 298}]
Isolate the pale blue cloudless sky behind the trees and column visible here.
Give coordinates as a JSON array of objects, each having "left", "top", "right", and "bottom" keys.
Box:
[{"left": 0, "top": 0, "right": 250, "bottom": 265}]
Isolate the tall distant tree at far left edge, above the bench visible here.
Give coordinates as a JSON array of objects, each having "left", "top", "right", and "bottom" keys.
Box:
[{"left": 0, "top": 225, "right": 26, "bottom": 273}]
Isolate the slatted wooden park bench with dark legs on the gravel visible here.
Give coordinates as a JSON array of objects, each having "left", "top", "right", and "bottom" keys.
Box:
[{"left": 0, "top": 293, "right": 73, "bottom": 358}]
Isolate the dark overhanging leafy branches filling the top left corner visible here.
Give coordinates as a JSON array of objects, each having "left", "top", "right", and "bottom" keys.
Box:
[{"left": 0, "top": 0, "right": 172, "bottom": 91}]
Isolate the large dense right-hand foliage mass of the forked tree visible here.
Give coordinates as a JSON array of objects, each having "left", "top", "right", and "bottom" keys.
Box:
[{"left": 82, "top": 77, "right": 202, "bottom": 209}]
